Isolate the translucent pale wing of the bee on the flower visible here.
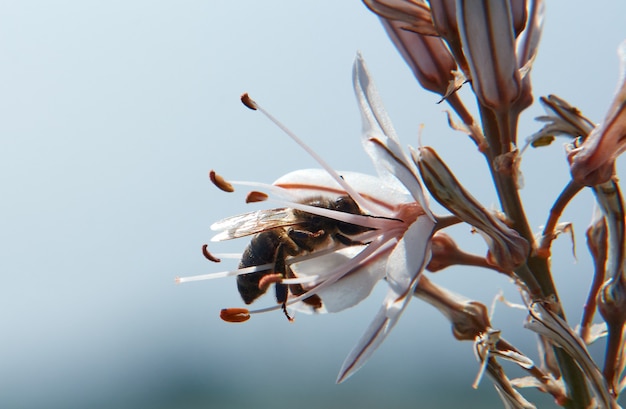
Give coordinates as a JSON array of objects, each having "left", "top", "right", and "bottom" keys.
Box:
[{"left": 211, "top": 208, "right": 301, "bottom": 241}]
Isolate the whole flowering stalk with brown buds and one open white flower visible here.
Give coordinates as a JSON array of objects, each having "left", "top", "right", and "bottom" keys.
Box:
[{"left": 178, "top": 0, "right": 626, "bottom": 409}]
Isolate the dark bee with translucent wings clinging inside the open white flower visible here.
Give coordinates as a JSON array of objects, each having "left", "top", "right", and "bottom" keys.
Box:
[{"left": 213, "top": 195, "right": 371, "bottom": 321}]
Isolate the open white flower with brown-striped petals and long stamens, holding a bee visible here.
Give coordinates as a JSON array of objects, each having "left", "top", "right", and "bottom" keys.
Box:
[{"left": 178, "top": 55, "right": 436, "bottom": 382}]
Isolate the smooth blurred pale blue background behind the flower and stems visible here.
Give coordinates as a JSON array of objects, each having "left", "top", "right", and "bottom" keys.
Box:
[{"left": 0, "top": 0, "right": 626, "bottom": 409}]
